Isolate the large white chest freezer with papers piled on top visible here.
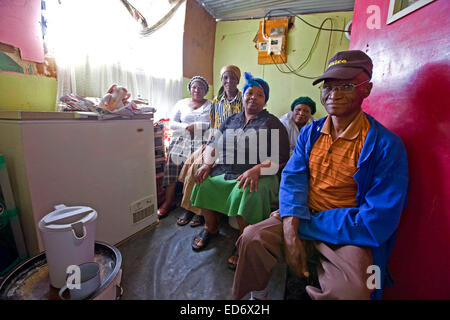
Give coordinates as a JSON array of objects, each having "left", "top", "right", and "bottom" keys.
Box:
[{"left": 0, "top": 111, "right": 157, "bottom": 256}]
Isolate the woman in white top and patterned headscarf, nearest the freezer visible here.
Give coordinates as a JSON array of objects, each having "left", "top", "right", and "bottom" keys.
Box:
[{"left": 158, "top": 76, "right": 212, "bottom": 218}]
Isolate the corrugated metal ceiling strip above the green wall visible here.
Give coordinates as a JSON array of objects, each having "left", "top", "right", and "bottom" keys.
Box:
[{"left": 197, "top": 0, "right": 355, "bottom": 20}]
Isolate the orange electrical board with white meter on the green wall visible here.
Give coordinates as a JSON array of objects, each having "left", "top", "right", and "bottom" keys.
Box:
[{"left": 255, "top": 18, "right": 289, "bottom": 64}]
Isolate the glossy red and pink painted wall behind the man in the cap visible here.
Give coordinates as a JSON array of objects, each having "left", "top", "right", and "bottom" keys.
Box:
[{"left": 350, "top": 0, "right": 450, "bottom": 299}]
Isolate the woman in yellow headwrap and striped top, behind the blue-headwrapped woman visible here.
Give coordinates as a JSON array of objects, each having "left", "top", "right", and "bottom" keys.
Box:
[{"left": 177, "top": 65, "right": 242, "bottom": 227}]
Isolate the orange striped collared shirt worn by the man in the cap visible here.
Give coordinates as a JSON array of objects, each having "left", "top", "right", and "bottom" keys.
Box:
[{"left": 308, "top": 111, "right": 370, "bottom": 211}]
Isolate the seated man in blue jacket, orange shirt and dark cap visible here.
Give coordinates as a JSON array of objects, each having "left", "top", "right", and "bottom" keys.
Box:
[{"left": 233, "top": 50, "right": 409, "bottom": 299}]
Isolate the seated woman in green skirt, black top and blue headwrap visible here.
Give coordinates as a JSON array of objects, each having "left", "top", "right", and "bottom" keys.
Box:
[{"left": 191, "top": 73, "right": 289, "bottom": 268}]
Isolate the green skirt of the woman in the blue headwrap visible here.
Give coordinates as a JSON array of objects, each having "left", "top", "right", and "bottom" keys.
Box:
[{"left": 191, "top": 174, "right": 279, "bottom": 224}]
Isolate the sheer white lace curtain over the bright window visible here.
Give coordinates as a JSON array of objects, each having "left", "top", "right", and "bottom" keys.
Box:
[{"left": 46, "top": 0, "right": 185, "bottom": 119}]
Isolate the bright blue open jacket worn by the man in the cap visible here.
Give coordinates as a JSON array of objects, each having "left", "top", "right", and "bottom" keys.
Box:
[{"left": 279, "top": 114, "right": 409, "bottom": 299}]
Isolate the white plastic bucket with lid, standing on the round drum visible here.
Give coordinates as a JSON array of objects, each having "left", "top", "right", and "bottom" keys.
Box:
[{"left": 39, "top": 205, "right": 97, "bottom": 288}]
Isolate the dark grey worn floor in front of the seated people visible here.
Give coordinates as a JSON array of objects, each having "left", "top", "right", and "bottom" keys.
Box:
[{"left": 118, "top": 208, "right": 286, "bottom": 300}]
